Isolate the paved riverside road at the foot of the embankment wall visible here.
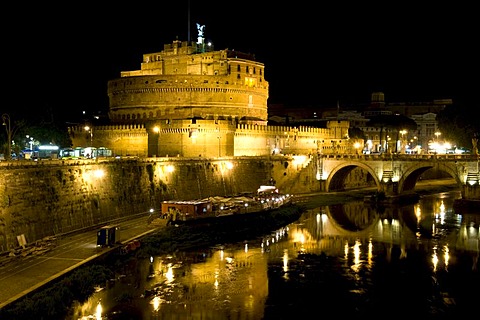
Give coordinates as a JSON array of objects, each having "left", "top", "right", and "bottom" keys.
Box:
[{"left": 0, "top": 213, "right": 166, "bottom": 309}]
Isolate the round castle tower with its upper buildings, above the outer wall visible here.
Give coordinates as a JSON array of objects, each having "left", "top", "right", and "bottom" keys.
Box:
[{"left": 108, "top": 40, "right": 268, "bottom": 125}]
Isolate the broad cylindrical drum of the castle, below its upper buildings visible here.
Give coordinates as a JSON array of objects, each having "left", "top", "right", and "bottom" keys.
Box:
[{"left": 109, "top": 75, "right": 268, "bottom": 122}]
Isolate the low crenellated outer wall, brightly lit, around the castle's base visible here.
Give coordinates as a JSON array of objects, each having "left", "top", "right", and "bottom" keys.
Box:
[{"left": 70, "top": 120, "right": 352, "bottom": 158}]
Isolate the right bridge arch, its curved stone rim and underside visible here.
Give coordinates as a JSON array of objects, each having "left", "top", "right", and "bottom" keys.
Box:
[{"left": 398, "top": 163, "right": 462, "bottom": 193}]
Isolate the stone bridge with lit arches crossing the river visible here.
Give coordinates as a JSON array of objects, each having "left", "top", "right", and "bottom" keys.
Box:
[{"left": 314, "top": 154, "right": 480, "bottom": 205}]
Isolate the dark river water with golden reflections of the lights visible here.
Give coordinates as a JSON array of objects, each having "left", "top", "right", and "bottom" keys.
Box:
[{"left": 75, "top": 192, "right": 480, "bottom": 319}]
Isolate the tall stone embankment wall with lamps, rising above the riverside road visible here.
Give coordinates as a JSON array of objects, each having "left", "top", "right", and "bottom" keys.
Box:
[{"left": 0, "top": 156, "right": 319, "bottom": 252}]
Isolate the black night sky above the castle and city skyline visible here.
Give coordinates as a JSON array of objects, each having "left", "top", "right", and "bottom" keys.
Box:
[{"left": 1, "top": 0, "right": 480, "bottom": 118}]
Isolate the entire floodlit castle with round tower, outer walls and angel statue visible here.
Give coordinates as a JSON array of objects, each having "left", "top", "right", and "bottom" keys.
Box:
[{"left": 69, "top": 31, "right": 354, "bottom": 158}]
